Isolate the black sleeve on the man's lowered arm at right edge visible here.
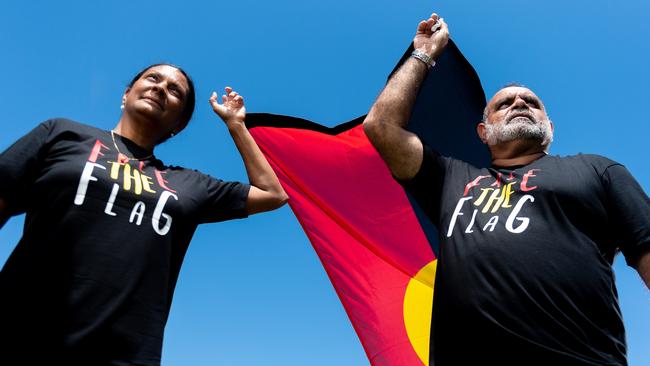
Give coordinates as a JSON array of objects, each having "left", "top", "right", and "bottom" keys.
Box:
[{"left": 602, "top": 164, "right": 650, "bottom": 266}]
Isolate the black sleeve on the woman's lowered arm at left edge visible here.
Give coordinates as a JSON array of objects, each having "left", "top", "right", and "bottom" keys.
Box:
[{"left": 0, "top": 120, "right": 55, "bottom": 215}]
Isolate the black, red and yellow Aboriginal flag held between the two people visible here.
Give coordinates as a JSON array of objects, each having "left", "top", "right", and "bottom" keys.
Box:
[{"left": 246, "top": 41, "right": 489, "bottom": 366}]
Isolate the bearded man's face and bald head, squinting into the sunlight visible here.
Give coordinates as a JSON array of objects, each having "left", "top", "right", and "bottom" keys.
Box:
[{"left": 479, "top": 87, "right": 553, "bottom": 148}]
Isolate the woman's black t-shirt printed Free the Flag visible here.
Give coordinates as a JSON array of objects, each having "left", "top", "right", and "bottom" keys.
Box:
[{"left": 0, "top": 119, "right": 249, "bottom": 365}]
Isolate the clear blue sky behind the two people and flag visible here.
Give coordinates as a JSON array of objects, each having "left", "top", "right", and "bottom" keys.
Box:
[{"left": 0, "top": 0, "right": 650, "bottom": 366}]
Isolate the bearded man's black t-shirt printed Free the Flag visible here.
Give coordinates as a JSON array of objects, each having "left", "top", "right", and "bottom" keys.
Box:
[{"left": 401, "top": 146, "right": 650, "bottom": 366}]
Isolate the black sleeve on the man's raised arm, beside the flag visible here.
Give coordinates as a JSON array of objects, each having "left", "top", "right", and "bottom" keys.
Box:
[{"left": 397, "top": 144, "right": 448, "bottom": 223}]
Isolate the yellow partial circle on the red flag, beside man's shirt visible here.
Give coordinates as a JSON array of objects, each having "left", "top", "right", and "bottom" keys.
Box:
[{"left": 404, "top": 260, "right": 438, "bottom": 366}]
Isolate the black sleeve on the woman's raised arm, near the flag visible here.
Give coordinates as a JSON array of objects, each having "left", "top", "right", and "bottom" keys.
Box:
[{"left": 198, "top": 175, "right": 250, "bottom": 223}]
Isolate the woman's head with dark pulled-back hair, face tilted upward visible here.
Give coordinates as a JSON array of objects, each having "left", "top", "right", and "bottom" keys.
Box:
[{"left": 122, "top": 65, "right": 189, "bottom": 137}]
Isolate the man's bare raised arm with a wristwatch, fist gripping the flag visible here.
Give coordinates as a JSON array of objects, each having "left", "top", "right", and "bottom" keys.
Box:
[{"left": 363, "top": 13, "right": 449, "bottom": 179}]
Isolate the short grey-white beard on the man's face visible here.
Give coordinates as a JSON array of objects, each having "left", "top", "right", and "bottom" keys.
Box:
[{"left": 485, "top": 114, "right": 553, "bottom": 147}]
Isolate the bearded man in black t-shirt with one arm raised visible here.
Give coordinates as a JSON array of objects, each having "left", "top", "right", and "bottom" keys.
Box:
[{"left": 364, "top": 14, "right": 650, "bottom": 366}]
